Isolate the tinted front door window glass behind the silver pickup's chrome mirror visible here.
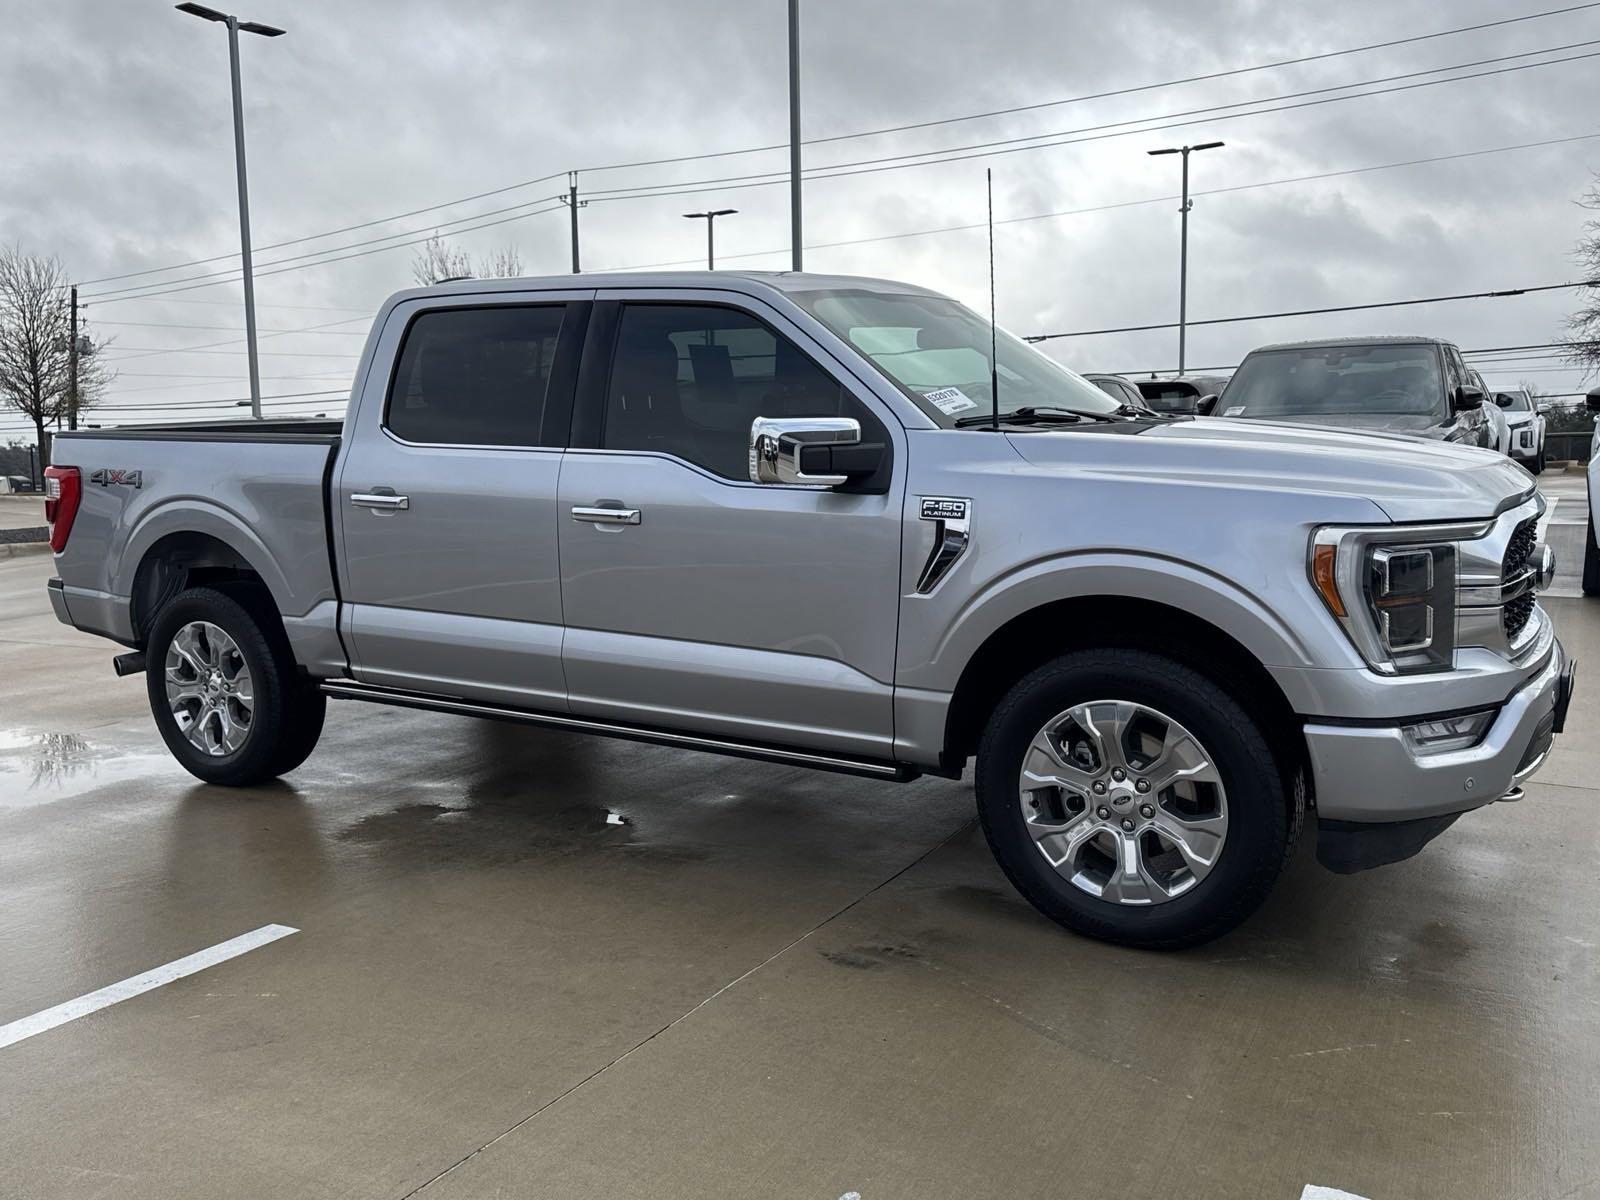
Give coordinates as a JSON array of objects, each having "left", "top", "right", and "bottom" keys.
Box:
[{"left": 602, "top": 304, "right": 880, "bottom": 480}]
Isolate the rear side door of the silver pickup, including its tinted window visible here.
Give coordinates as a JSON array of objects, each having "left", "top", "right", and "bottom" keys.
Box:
[{"left": 333, "top": 291, "right": 594, "bottom": 709}]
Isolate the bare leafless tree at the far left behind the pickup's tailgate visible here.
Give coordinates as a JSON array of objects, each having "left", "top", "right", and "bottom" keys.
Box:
[{"left": 0, "top": 246, "right": 110, "bottom": 461}]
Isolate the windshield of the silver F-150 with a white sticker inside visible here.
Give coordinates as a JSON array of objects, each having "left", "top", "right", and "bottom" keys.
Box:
[{"left": 794, "top": 290, "right": 1122, "bottom": 429}]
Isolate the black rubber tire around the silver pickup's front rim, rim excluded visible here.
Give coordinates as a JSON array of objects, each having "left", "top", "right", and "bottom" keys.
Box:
[{"left": 976, "top": 650, "right": 1304, "bottom": 949}]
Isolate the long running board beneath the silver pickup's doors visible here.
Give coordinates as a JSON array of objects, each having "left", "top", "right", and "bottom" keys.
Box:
[{"left": 322, "top": 680, "right": 922, "bottom": 784}]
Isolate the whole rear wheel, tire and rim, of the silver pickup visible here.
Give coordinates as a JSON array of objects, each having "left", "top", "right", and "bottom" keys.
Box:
[{"left": 146, "top": 587, "right": 326, "bottom": 787}]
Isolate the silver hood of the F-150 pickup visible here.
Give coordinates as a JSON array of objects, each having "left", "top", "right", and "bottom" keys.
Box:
[{"left": 1011, "top": 416, "right": 1533, "bottom": 522}]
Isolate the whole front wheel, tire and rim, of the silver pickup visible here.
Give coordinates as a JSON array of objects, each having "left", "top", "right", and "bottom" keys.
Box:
[{"left": 976, "top": 650, "right": 1302, "bottom": 949}]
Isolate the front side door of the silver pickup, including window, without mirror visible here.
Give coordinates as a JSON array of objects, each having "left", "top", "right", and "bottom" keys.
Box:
[{"left": 558, "top": 293, "right": 906, "bottom": 758}]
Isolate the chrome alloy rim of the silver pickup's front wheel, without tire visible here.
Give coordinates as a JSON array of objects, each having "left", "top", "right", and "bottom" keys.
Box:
[{"left": 1019, "top": 701, "right": 1227, "bottom": 906}]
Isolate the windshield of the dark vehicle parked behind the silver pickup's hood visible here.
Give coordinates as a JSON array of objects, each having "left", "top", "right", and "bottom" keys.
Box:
[{"left": 1221, "top": 342, "right": 1445, "bottom": 419}]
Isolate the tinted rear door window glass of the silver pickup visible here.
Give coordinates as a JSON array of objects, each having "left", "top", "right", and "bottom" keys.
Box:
[{"left": 384, "top": 304, "right": 566, "bottom": 446}]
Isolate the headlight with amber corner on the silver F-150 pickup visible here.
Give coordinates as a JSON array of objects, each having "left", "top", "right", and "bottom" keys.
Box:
[{"left": 1310, "top": 525, "right": 1483, "bottom": 675}]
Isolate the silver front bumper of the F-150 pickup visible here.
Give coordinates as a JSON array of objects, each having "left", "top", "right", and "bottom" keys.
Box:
[{"left": 1306, "top": 638, "right": 1574, "bottom": 825}]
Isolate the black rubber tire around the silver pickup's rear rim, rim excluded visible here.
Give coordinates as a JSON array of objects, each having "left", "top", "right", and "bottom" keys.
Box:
[{"left": 146, "top": 586, "right": 326, "bottom": 787}]
